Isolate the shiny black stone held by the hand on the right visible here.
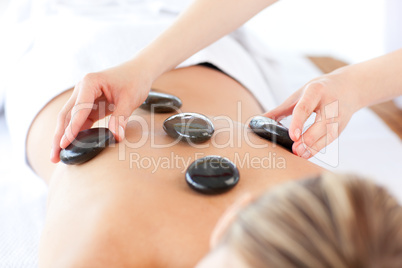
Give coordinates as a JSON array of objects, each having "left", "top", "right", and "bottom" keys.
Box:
[{"left": 250, "top": 116, "right": 293, "bottom": 151}]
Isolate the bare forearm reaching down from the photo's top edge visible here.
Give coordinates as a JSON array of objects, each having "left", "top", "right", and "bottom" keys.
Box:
[{"left": 134, "top": 0, "right": 276, "bottom": 78}]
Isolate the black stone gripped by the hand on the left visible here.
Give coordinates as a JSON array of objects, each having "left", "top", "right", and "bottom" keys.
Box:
[{"left": 60, "top": 128, "right": 115, "bottom": 165}]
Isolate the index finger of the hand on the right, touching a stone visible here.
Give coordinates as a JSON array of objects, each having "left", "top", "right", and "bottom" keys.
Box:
[{"left": 289, "top": 84, "right": 321, "bottom": 141}]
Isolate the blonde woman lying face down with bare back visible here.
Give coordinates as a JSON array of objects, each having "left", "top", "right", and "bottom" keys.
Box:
[{"left": 27, "top": 63, "right": 402, "bottom": 267}]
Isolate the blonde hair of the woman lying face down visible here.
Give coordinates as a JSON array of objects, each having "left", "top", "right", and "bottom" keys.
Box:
[{"left": 222, "top": 173, "right": 402, "bottom": 268}]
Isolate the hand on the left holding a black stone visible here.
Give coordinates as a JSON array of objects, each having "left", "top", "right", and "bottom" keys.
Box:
[{"left": 50, "top": 62, "right": 152, "bottom": 163}]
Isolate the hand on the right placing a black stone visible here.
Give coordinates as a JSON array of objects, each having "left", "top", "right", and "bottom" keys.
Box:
[{"left": 264, "top": 71, "right": 359, "bottom": 159}]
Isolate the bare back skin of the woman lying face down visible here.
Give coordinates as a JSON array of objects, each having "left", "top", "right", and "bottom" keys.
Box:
[{"left": 27, "top": 66, "right": 321, "bottom": 268}]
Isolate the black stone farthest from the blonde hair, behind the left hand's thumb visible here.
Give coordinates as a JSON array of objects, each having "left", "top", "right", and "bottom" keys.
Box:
[{"left": 140, "top": 91, "right": 182, "bottom": 113}]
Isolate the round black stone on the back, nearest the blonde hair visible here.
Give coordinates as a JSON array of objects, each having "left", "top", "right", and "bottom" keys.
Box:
[{"left": 186, "top": 155, "right": 240, "bottom": 194}]
